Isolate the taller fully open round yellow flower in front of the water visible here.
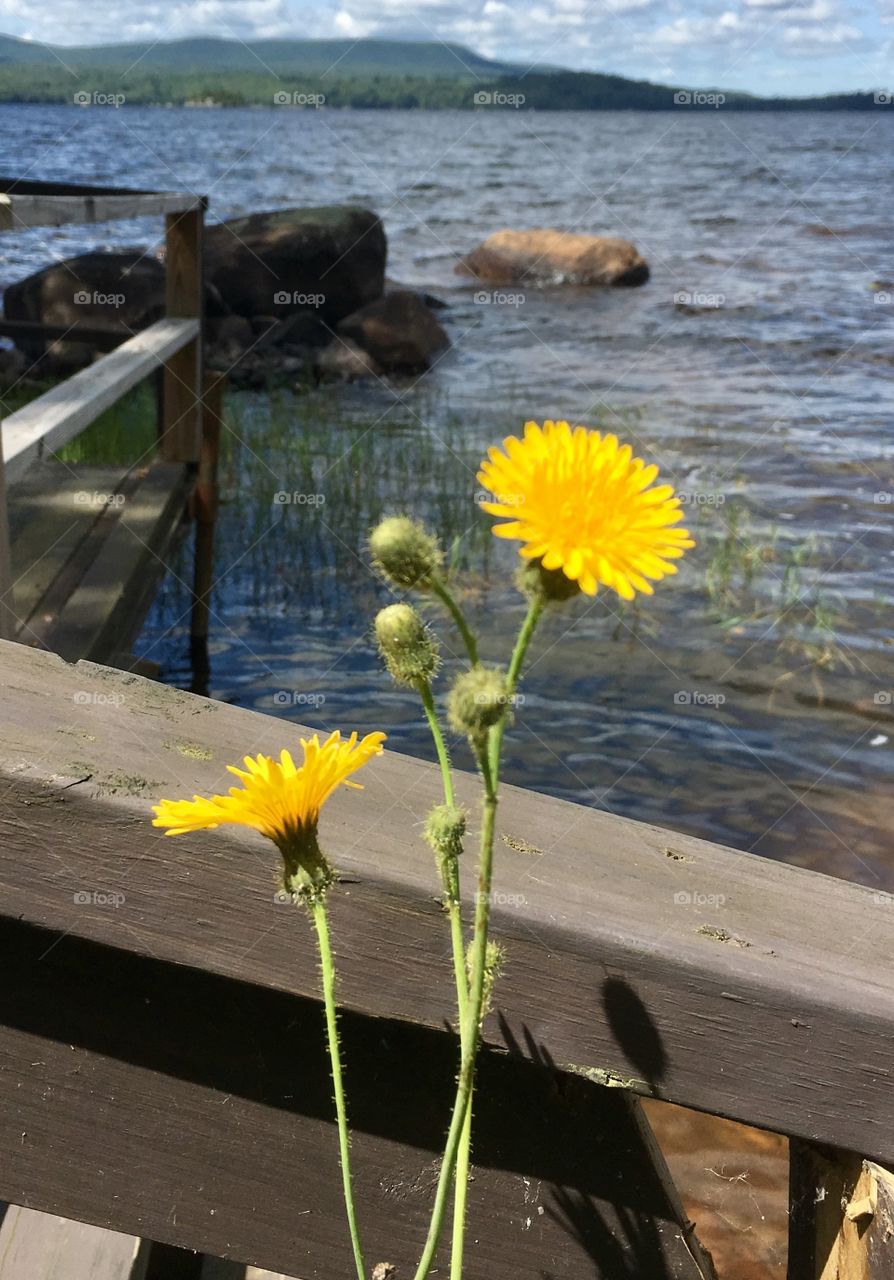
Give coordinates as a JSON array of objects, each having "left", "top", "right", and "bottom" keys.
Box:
[{"left": 478, "top": 422, "right": 695, "bottom": 600}]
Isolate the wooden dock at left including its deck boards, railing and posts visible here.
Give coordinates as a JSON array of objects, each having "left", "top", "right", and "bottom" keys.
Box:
[{"left": 0, "top": 179, "right": 212, "bottom": 667}]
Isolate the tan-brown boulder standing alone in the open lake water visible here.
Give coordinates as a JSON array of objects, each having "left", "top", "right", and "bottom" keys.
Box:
[{"left": 456, "top": 228, "right": 649, "bottom": 284}]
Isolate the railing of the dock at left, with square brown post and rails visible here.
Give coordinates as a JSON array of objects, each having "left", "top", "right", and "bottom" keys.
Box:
[{"left": 0, "top": 179, "right": 206, "bottom": 639}]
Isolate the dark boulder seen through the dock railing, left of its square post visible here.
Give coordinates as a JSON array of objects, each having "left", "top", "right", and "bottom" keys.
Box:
[{"left": 3, "top": 250, "right": 164, "bottom": 369}]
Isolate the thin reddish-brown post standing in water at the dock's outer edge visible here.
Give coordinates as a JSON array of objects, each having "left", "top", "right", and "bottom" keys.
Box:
[{"left": 190, "top": 372, "right": 224, "bottom": 694}]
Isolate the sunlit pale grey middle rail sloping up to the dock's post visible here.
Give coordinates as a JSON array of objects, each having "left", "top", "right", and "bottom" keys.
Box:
[{"left": 0, "top": 319, "right": 199, "bottom": 484}]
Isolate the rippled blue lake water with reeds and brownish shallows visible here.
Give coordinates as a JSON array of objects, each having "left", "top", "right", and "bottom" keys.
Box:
[{"left": 0, "top": 106, "right": 894, "bottom": 888}]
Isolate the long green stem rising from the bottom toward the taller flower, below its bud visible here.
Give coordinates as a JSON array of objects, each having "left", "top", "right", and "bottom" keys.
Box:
[{"left": 415, "top": 751, "right": 497, "bottom": 1280}]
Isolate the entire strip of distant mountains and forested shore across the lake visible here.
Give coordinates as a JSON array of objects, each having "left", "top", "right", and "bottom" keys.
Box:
[{"left": 0, "top": 35, "right": 890, "bottom": 111}]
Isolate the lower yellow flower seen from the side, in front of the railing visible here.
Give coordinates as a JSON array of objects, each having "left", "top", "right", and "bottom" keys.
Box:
[{"left": 152, "top": 732, "right": 386, "bottom": 892}]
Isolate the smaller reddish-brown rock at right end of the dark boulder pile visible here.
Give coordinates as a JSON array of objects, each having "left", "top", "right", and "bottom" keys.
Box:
[{"left": 338, "top": 289, "right": 450, "bottom": 374}]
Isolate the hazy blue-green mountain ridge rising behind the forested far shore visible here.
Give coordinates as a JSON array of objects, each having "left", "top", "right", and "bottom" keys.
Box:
[{"left": 0, "top": 36, "right": 526, "bottom": 81}]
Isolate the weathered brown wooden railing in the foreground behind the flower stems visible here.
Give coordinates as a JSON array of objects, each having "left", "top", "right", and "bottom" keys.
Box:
[{"left": 0, "top": 644, "right": 894, "bottom": 1280}]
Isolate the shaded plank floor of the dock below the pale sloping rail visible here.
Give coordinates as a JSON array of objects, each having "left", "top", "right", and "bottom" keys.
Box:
[{"left": 8, "top": 460, "right": 191, "bottom": 666}]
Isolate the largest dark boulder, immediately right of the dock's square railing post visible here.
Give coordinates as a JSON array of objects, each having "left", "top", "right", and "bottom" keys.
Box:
[{"left": 205, "top": 206, "right": 387, "bottom": 325}]
